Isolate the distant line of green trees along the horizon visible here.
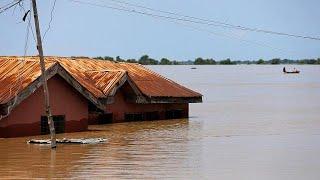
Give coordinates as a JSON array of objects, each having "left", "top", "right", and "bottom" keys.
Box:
[{"left": 94, "top": 55, "right": 320, "bottom": 65}]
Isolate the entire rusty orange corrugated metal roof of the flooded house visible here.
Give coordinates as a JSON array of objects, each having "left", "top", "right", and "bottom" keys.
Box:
[{"left": 0, "top": 56, "right": 202, "bottom": 104}]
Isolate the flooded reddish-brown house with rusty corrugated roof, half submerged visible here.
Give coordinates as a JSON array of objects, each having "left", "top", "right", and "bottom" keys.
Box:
[{"left": 0, "top": 57, "right": 202, "bottom": 137}]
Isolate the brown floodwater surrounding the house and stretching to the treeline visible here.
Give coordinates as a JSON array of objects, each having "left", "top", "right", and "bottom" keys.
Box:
[{"left": 0, "top": 66, "right": 320, "bottom": 179}]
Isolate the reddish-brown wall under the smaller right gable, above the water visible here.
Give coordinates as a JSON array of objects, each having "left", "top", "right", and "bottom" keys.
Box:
[{"left": 106, "top": 89, "right": 189, "bottom": 122}]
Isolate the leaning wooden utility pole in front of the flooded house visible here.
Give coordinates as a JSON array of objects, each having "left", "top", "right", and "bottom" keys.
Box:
[{"left": 32, "top": 0, "right": 57, "bottom": 148}]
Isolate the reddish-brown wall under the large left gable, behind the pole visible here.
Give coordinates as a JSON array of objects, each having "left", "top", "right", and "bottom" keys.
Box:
[{"left": 0, "top": 75, "right": 88, "bottom": 137}]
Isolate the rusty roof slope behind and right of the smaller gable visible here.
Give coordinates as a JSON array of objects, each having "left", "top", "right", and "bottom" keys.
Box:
[{"left": 56, "top": 58, "right": 202, "bottom": 97}]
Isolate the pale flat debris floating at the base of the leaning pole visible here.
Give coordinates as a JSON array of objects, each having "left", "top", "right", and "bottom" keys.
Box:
[{"left": 27, "top": 138, "right": 107, "bottom": 144}]
